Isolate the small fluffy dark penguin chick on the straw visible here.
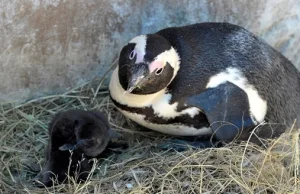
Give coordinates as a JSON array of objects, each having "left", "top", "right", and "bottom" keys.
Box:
[{"left": 35, "top": 110, "right": 117, "bottom": 186}]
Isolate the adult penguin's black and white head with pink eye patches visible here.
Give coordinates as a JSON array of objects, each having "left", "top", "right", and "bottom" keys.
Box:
[{"left": 118, "top": 34, "right": 180, "bottom": 95}]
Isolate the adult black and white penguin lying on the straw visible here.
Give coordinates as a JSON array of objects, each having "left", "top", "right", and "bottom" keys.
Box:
[{"left": 109, "top": 23, "right": 300, "bottom": 142}]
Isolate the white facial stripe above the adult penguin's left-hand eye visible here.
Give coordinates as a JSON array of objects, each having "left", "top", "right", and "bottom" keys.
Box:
[{"left": 129, "top": 35, "right": 147, "bottom": 63}]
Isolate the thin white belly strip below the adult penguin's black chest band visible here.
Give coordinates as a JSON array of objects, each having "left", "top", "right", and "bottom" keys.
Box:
[{"left": 118, "top": 109, "right": 212, "bottom": 136}]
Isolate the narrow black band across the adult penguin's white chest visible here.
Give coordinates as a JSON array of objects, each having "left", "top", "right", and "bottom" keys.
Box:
[{"left": 111, "top": 97, "right": 209, "bottom": 129}]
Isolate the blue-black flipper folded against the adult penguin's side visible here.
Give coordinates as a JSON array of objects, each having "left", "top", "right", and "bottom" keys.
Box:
[{"left": 185, "top": 82, "right": 255, "bottom": 141}]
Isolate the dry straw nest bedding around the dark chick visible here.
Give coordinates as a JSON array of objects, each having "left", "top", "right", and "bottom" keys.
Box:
[{"left": 0, "top": 62, "right": 300, "bottom": 193}]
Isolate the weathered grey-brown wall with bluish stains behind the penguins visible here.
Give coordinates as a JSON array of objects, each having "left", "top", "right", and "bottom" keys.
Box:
[{"left": 0, "top": 0, "right": 300, "bottom": 103}]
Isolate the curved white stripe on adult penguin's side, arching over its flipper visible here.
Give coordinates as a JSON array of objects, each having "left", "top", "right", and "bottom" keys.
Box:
[{"left": 206, "top": 67, "right": 267, "bottom": 122}]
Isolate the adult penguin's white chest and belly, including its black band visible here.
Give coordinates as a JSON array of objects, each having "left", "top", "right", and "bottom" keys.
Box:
[{"left": 109, "top": 68, "right": 212, "bottom": 136}]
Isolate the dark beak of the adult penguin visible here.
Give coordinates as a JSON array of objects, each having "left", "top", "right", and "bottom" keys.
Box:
[{"left": 126, "top": 63, "right": 149, "bottom": 93}]
